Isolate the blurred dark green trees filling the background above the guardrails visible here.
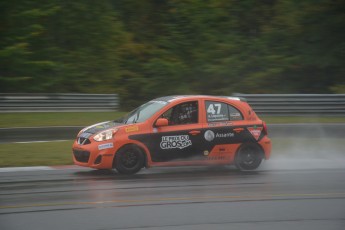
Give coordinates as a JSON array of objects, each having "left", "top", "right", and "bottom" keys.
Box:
[{"left": 0, "top": 0, "right": 345, "bottom": 108}]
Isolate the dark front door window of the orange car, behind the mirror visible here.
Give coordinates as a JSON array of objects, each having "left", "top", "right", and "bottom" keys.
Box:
[{"left": 161, "top": 101, "right": 199, "bottom": 125}]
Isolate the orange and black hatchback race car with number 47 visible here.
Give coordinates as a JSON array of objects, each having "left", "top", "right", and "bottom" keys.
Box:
[{"left": 73, "top": 96, "right": 271, "bottom": 174}]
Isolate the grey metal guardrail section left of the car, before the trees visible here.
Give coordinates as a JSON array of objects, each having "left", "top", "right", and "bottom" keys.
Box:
[{"left": 0, "top": 93, "right": 119, "bottom": 113}]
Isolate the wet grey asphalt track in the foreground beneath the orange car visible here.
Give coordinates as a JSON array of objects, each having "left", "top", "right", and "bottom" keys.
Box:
[{"left": 0, "top": 164, "right": 345, "bottom": 230}]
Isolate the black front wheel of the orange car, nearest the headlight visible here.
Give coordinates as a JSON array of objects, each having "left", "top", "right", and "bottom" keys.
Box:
[{"left": 115, "top": 145, "right": 145, "bottom": 174}]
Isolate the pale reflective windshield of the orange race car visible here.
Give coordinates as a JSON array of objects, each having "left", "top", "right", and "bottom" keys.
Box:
[{"left": 117, "top": 101, "right": 168, "bottom": 124}]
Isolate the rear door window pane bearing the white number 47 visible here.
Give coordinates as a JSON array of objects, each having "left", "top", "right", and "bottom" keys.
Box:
[{"left": 206, "top": 101, "right": 229, "bottom": 122}]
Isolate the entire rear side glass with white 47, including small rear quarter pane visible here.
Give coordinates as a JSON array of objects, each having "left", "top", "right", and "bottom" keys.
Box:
[{"left": 205, "top": 101, "right": 243, "bottom": 122}]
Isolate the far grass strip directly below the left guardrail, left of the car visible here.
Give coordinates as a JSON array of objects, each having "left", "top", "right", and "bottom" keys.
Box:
[{"left": 0, "top": 112, "right": 126, "bottom": 128}]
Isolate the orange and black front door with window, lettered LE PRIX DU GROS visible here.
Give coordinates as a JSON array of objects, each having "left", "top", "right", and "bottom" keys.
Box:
[{"left": 130, "top": 100, "right": 203, "bottom": 162}]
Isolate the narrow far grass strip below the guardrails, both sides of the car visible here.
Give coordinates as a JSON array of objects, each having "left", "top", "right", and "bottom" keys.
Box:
[{"left": 0, "top": 112, "right": 345, "bottom": 128}]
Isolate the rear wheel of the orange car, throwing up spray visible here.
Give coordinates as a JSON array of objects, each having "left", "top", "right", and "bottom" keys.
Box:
[{"left": 235, "top": 143, "right": 263, "bottom": 171}]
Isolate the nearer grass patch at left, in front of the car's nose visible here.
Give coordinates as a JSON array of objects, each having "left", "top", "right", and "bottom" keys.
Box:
[{"left": 0, "top": 141, "right": 73, "bottom": 167}]
